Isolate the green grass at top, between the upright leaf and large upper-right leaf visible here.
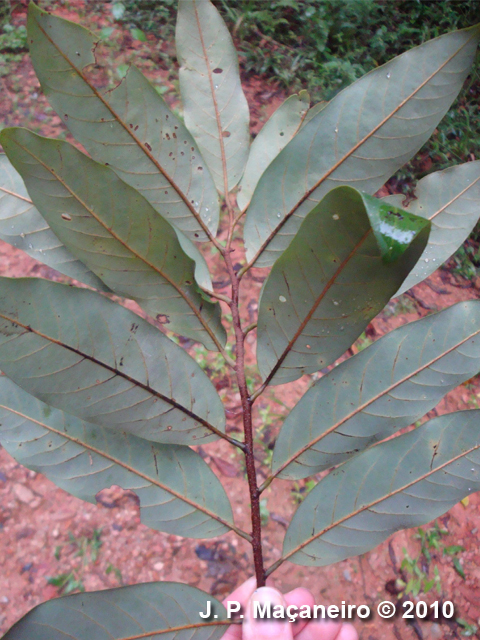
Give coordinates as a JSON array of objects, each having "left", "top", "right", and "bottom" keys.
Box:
[{"left": 215, "top": 0, "right": 480, "bottom": 101}]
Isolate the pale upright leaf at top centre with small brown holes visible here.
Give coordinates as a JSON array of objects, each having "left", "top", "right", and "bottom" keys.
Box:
[{"left": 176, "top": 0, "right": 250, "bottom": 193}]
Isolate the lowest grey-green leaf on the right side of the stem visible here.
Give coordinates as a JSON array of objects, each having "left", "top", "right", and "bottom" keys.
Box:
[{"left": 283, "top": 410, "right": 480, "bottom": 567}]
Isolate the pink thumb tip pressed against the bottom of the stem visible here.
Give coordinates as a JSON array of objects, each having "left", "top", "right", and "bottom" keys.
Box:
[{"left": 243, "top": 587, "right": 293, "bottom": 640}]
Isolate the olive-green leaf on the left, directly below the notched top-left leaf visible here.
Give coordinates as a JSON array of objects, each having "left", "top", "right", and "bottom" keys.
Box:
[{"left": 0, "top": 128, "right": 226, "bottom": 350}]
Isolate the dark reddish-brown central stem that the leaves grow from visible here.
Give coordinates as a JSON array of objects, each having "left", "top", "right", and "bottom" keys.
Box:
[{"left": 225, "top": 251, "right": 266, "bottom": 587}]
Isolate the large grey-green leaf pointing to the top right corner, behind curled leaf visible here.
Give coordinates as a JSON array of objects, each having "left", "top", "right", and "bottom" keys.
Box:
[{"left": 245, "top": 26, "right": 480, "bottom": 267}]
